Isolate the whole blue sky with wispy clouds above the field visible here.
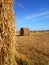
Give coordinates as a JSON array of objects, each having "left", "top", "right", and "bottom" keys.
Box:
[{"left": 14, "top": 0, "right": 49, "bottom": 31}]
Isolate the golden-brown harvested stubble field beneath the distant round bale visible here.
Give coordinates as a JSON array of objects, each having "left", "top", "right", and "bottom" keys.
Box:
[{"left": 17, "top": 32, "right": 49, "bottom": 65}]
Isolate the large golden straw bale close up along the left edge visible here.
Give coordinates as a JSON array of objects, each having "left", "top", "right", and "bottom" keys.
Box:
[{"left": 0, "top": 0, "right": 17, "bottom": 65}]
